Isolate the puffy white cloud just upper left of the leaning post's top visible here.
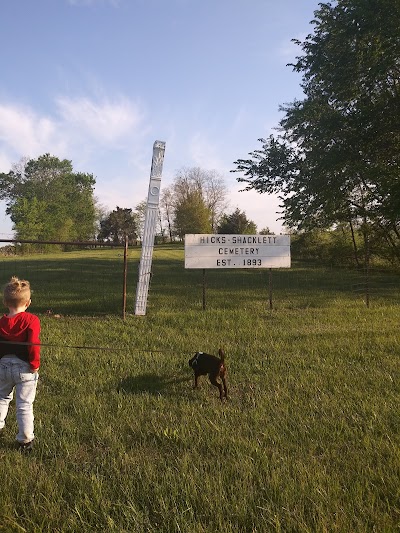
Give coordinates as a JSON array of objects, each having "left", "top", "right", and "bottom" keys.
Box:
[{"left": 57, "top": 97, "right": 143, "bottom": 144}]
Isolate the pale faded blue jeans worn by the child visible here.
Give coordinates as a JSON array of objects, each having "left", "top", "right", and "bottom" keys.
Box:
[{"left": 0, "top": 355, "right": 39, "bottom": 444}]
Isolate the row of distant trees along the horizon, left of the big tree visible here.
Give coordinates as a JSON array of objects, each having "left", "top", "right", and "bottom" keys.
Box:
[{"left": 0, "top": 154, "right": 257, "bottom": 248}]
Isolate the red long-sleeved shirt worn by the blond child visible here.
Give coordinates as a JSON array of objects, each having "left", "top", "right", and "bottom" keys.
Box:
[{"left": 0, "top": 311, "right": 40, "bottom": 370}]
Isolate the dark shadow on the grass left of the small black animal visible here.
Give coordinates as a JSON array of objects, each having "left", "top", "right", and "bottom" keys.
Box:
[{"left": 117, "top": 374, "right": 189, "bottom": 395}]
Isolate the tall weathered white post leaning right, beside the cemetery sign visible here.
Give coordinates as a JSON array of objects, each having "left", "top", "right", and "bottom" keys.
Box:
[{"left": 135, "top": 141, "right": 165, "bottom": 315}]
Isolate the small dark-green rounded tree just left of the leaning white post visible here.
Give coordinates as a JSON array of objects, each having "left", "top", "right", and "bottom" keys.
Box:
[{"left": 98, "top": 206, "right": 137, "bottom": 244}]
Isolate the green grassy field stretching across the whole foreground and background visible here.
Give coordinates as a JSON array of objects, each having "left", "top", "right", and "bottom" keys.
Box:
[{"left": 0, "top": 247, "right": 400, "bottom": 533}]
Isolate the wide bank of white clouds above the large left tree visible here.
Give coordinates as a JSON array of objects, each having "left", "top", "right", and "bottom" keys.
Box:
[{"left": 0, "top": 97, "right": 149, "bottom": 180}]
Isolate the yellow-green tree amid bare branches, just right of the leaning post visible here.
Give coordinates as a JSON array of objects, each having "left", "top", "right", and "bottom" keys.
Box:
[{"left": 175, "top": 191, "right": 211, "bottom": 239}]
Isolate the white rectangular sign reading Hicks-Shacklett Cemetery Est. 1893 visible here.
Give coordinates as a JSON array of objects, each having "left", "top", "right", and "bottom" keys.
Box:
[{"left": 185, "top": 234, "right": 290, "bottom": 269}]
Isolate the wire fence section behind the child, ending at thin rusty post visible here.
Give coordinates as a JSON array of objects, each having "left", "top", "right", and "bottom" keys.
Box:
[{"left": 0, "top": 239, "right": 132, "bottom": 316}]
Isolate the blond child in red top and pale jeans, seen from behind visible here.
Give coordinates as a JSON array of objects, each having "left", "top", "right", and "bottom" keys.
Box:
[{"left": 0, "top": 276, "right": 40, "bottom": 451}]
